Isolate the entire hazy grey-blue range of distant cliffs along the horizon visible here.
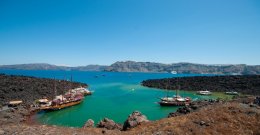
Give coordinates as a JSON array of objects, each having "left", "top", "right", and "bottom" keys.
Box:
[{"left": 0, "top": 61, "right": 260, "bottom": 75}]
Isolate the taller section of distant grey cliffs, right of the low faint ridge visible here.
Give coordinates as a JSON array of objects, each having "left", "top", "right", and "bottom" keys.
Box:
[{"left": 105, "top": 61, "right": 260, "bottom": 75}]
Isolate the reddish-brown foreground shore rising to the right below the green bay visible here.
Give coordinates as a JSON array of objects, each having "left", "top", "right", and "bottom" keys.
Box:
[{"left": 0, "top": 96, "right": 260, "bottom": 135}]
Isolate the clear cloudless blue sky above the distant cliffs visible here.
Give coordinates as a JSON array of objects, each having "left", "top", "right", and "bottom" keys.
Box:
[{"left": 0, "top": 0, "right": 260, "bottom": 66}]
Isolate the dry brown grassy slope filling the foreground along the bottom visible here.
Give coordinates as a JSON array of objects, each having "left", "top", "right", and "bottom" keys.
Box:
[{"left": 0, "top": 98, "right": 260, "bottom": 135}]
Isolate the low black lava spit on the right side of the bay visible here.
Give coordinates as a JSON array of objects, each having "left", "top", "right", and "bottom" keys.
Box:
[{"left": 142, "top": 75, "right": 260, "bottom": 95}]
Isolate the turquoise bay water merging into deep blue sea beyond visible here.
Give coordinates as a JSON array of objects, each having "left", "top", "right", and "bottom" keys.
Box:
[{"left": 0, "top": 70, "right": 215, "bottom": 127}]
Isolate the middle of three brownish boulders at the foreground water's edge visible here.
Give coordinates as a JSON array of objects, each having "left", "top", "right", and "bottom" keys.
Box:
[{"left": 97, "top": 118, "right": 122, "bottom": 130}]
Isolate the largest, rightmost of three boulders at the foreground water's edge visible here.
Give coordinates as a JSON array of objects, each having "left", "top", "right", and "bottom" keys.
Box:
[{"left": 123, "top": 111, "right": 149, "bottom": 130}]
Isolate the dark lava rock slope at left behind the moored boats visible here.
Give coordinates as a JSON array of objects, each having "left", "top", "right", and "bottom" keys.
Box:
[{"left": 0, "top": 74, "right": 87, "bottom": 105}]
